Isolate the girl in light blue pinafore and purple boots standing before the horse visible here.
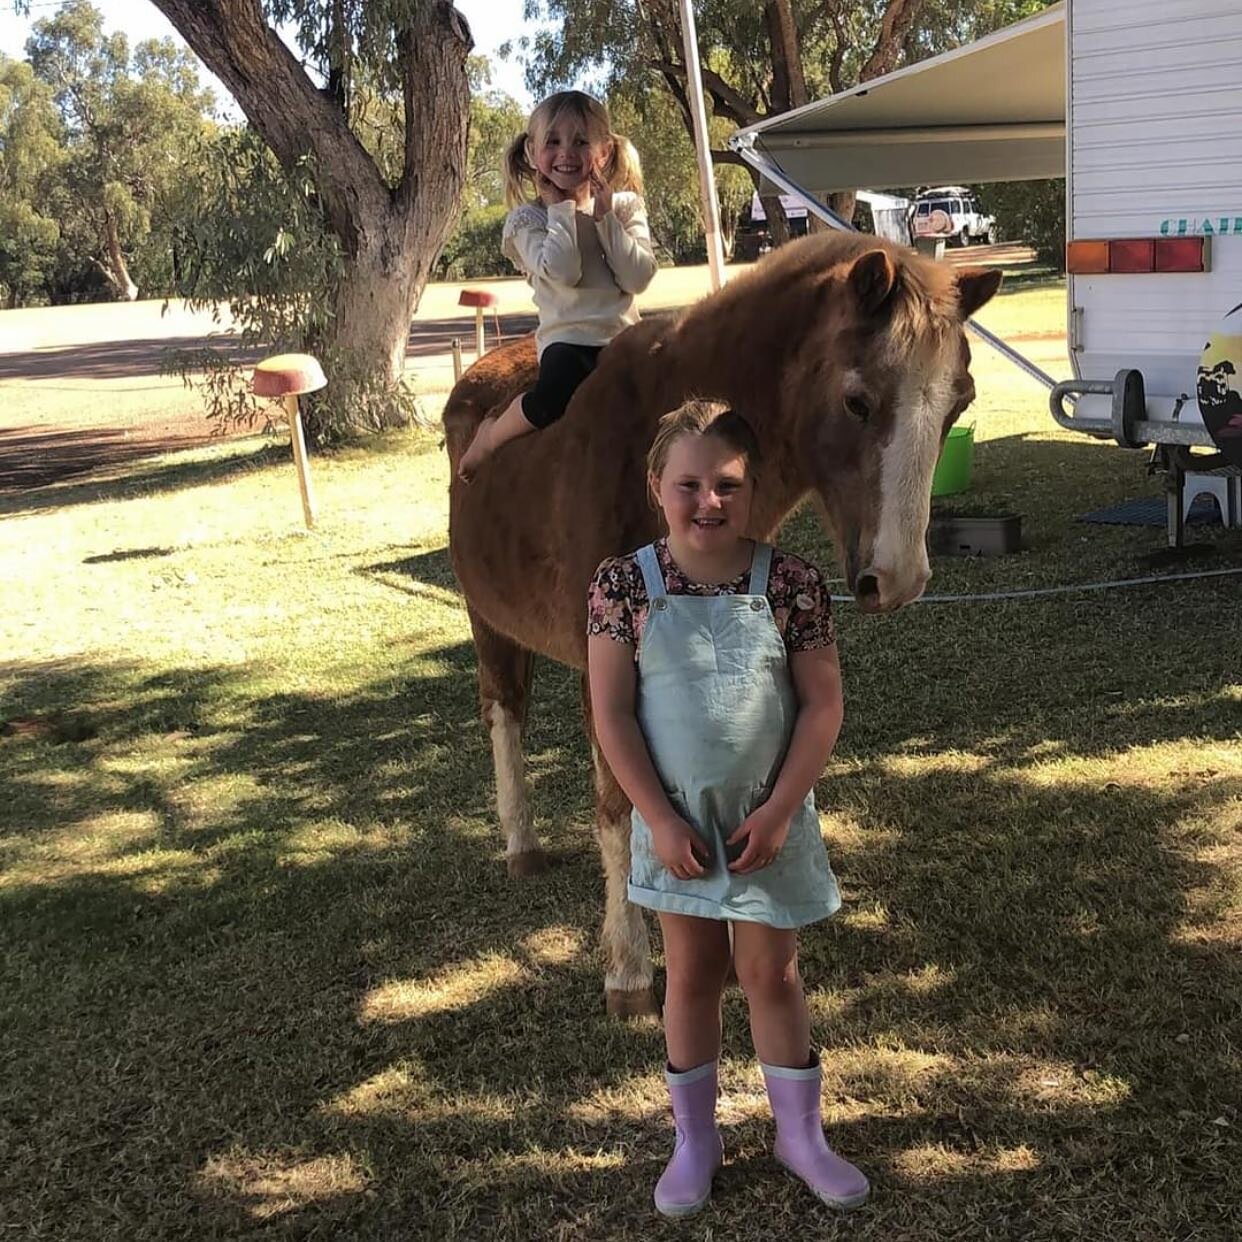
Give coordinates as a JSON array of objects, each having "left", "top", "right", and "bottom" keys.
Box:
[{"left": 587, "top": 401, "right": 869, "bottom": 1216}]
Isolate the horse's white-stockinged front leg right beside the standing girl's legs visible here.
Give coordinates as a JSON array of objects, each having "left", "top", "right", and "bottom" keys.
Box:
[{"left": 591, "top": 740, "right": 660, "bottom": 1017}]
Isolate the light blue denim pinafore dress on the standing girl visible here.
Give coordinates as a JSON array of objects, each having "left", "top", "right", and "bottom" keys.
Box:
[{"left": 628, "top": 544, "right": 841, "bottom": 928}]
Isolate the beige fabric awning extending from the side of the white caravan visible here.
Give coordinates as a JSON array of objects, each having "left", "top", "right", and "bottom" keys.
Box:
[{"left": 729, "top": 2, "right": 1066, "bottom": 194}]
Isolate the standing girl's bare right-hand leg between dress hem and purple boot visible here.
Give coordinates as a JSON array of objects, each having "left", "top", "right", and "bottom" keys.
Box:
[{"left": 733, "top": 923, "right": 811, "bottom": 1067}]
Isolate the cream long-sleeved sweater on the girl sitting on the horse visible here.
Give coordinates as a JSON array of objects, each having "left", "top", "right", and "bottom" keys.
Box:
[{"left": 502, "top": 193, "right": 656, "bottom": 354}]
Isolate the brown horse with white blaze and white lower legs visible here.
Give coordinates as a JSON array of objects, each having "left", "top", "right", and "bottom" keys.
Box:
[{"left": 445, "top": 233, "right": 1000, "bottom": 1015}]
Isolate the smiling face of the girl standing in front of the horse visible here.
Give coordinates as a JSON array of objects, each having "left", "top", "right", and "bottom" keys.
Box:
[{"left": 650, "top": 432, "right": 755, "bottom": 556}]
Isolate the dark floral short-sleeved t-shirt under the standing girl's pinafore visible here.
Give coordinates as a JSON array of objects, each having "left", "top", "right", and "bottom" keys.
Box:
[{"left": 586, "top": 539, "right": 837, "bottom": 660}]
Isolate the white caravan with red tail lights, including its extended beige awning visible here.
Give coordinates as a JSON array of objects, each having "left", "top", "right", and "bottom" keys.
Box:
[{"left": 730, "top": 0, "right": 1242, "bottom": 543}]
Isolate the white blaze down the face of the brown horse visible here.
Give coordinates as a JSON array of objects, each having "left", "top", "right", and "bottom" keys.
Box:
[{"left": 864, "top": 349, "right": 954, "bottom": 606}]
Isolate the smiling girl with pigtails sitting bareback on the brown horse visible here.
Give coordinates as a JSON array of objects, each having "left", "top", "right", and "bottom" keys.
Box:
[{"left": 457, "top": 91, "right": 656, "bottom": 482}]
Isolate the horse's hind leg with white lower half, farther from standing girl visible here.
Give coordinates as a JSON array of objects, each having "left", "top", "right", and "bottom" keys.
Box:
[{"left": 467, "top": 609, "right": 545, "bottom": 877}]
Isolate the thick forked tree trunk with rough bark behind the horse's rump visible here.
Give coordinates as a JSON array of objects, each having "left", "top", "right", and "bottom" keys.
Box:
[{"left": 153, "top": 0, "right": 473, "bottom": 438}]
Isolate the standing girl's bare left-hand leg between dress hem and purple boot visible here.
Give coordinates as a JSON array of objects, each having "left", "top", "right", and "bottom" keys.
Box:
[{"left": 660, "top": 912, "right": 729, "bottom": 1071}]
